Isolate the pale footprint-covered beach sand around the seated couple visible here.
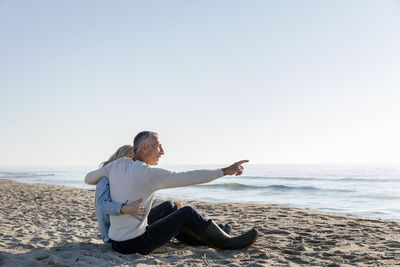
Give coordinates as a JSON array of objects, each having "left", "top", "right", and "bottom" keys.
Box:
[{"left": 0, "top": 180, "right": 400, "bottom": 267}]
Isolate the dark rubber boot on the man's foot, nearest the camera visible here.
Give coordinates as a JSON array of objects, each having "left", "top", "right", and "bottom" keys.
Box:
[{"left": 198, "top": 222, "right": 258, "bottom": 249}]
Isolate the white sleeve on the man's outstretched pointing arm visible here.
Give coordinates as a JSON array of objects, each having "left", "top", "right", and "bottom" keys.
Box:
[{"left": 147, "top": 167, "right": 224, "bottom": 191}]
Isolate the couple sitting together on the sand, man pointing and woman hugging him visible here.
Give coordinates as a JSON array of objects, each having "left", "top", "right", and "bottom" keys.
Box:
[{"left": 85, "top": 131, "right": 257, "bottom": 254}]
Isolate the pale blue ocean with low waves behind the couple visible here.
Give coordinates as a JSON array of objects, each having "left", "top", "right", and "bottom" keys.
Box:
[{"left": 0, "top": 164, "right": 400, "bottom": 221}]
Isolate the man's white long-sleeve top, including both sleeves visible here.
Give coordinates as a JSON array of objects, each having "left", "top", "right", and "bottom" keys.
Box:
[{"left": 85, "top": 158, "right": 223, "bottom": 241}]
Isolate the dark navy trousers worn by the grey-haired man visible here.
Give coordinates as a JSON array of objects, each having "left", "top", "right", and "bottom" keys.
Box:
[{"left": 111, "top": 202, "right": 211, "bottom": 254}]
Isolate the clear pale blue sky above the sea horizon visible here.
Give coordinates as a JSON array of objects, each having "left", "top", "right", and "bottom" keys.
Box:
[{"left": 0, "top": 0, "right": 400, "bottom": 167}]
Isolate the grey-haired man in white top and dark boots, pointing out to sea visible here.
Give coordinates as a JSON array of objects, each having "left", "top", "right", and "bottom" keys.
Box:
[{"left": 85, "top": 131, "right": 257, "bottom": 254}]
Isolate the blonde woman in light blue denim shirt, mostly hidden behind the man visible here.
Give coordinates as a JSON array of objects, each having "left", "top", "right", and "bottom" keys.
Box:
[{"left": 95, "top": 145, "right": 231, "bottom": 245}]
